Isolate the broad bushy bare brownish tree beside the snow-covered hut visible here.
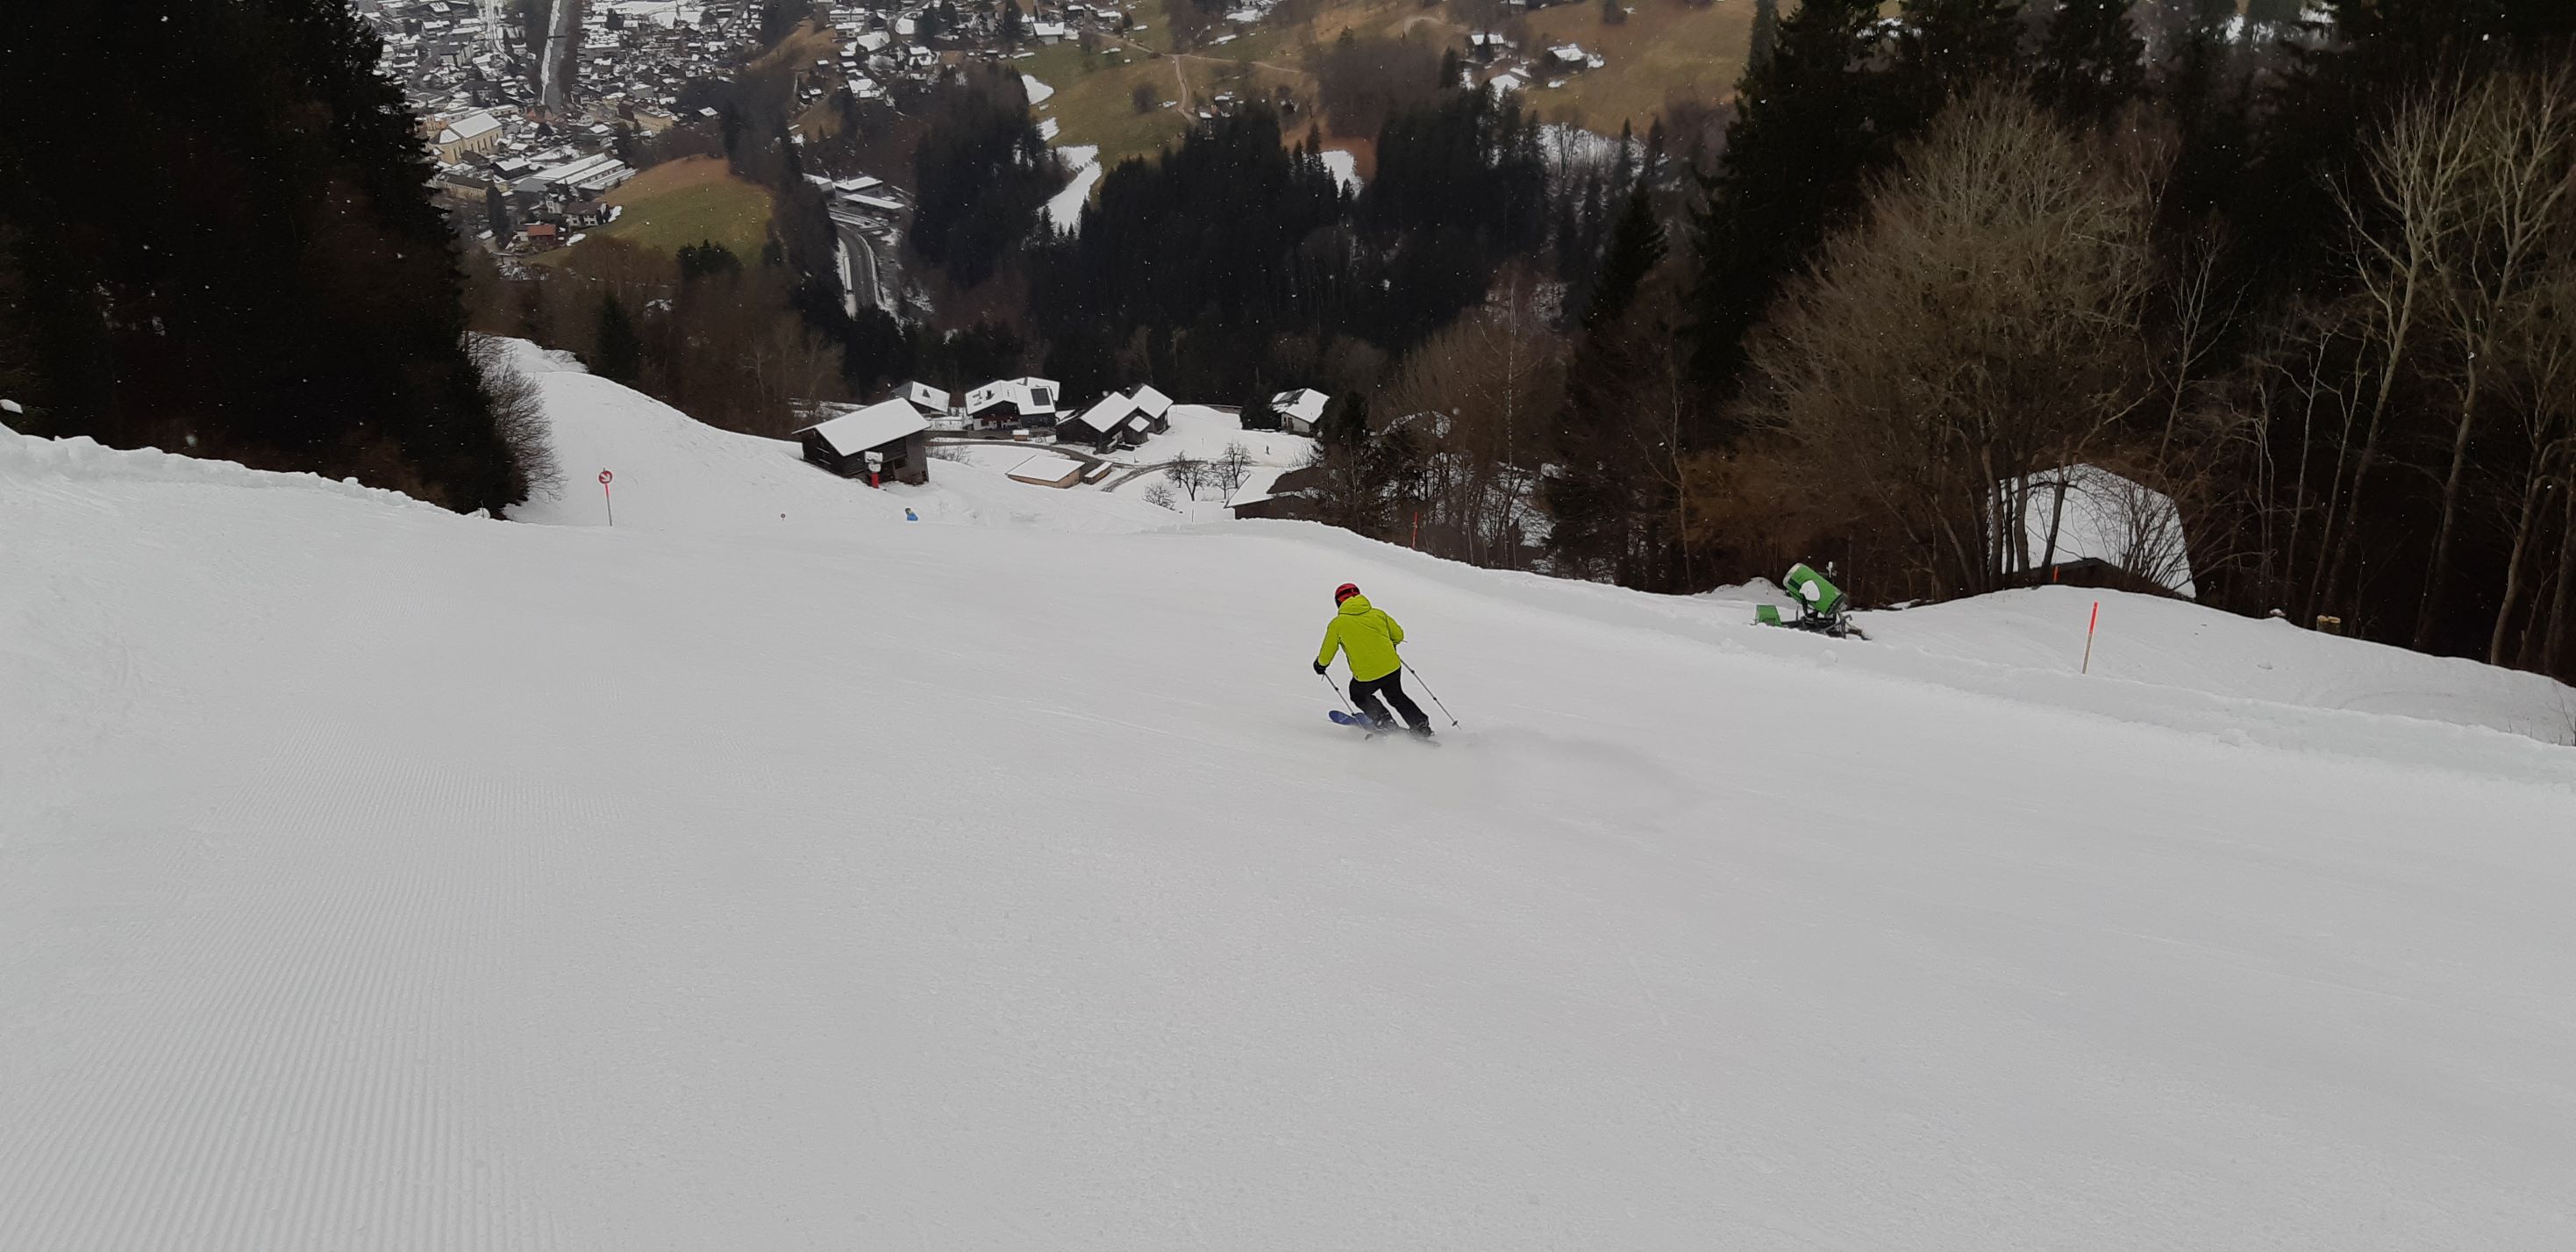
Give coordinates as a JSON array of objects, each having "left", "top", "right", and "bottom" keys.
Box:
[{"left": 1744, "top": 85, "right": 2164, "bottom": 603}]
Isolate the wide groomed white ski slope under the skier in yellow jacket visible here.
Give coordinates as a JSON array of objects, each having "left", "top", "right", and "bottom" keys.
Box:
[{"left": 0, "top": 414, "right": 2576, "bottom": 1252}]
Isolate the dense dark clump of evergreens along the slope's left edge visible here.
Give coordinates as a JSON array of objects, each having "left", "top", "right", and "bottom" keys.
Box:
[{"left": 0, "top": 0, "right": 525, "bottom": 510}]
